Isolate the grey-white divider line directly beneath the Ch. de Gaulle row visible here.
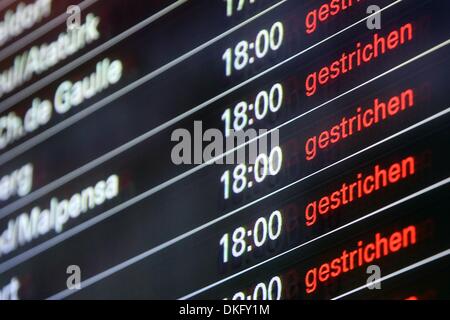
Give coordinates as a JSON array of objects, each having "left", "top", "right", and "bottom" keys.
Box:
[{"left": 0, "top": 0, "right": 287, "bottom": 165}]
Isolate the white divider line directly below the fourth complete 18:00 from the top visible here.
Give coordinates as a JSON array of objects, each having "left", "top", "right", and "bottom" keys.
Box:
[{"left": 176, "top": 177, "right": 450, "bottom": 300}]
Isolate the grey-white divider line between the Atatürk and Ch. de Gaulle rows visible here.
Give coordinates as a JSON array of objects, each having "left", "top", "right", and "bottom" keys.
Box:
[{"left": 0, "top": 0, "right": 188, "bottom": 112}]
